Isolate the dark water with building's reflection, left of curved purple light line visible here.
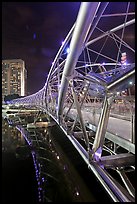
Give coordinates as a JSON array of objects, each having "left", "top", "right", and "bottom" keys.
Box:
[{"left": 2, "top": 120, "right": 36, "bottom": 203}]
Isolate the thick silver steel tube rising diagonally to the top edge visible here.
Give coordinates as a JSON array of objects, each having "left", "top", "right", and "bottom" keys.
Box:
[{"left": 58, "top": 2, "right": 100, "bottom": 121}]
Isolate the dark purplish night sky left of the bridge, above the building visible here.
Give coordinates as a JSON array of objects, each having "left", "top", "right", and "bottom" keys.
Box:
[{"left": 2, "top": 2, "right": 80, "bottom": 94}]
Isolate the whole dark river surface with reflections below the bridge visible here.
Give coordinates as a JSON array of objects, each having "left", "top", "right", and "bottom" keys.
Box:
[{"left": 2, "top": 117, "right": 134, "bottom": 203}]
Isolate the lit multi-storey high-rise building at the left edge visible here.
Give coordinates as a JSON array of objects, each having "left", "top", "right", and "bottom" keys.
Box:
[{"left": 2, "top": 59, "right": 27, "bottom": 100}]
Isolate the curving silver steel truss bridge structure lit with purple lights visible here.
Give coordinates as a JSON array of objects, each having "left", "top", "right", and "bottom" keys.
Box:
[{"left": 7, "top": 2, "right": 135, "bottom": 202}]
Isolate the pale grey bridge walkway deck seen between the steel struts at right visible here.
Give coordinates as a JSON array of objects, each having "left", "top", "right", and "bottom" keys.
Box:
[{"left": 65, "top": 109, "right": 135, "bottom": 153}]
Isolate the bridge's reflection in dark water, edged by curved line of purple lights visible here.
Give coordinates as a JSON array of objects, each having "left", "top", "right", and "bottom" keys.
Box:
[{"left": 17, "top": 122, "right": 95, "bottom": 202}]
